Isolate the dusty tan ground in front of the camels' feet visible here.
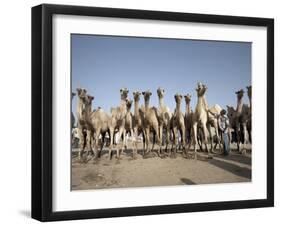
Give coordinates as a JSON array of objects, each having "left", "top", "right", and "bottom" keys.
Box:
[{"left": 72, "top": 144, "right": 251, "bottom": 190}]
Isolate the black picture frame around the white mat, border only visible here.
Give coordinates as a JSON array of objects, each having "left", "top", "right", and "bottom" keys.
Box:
[{"left": 32, "top": 4, "right": 274, "bottom": 221}]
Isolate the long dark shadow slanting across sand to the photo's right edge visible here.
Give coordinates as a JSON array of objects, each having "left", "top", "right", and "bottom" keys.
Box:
[{"left": 209, "top": 159, "right": 249, "bottom": 179}]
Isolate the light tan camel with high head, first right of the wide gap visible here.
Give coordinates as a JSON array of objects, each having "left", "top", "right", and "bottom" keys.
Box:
[{"left": 109, "top": 88, "right": 129, "bottom": 159}]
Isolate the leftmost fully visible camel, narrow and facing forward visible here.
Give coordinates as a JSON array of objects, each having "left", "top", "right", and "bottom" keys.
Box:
[{"left": 76, "top": 88, "right": 87, "bottom": 160}]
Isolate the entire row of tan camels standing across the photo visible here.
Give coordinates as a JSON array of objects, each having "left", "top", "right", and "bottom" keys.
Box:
[{"left": 72, "top": 83, "right": 252, "bottom": 160}]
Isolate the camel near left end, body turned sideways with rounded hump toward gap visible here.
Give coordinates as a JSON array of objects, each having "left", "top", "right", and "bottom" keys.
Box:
[{"left": 84, "top": 95, "right": 110, "bottom": 159}]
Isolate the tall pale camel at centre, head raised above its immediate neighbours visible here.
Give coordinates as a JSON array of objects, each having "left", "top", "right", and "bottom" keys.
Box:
[{"left": 157, "top": 87, "right": 172, "bottom": 150}]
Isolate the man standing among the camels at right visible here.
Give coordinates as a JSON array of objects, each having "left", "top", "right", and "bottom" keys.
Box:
[{"left": 219, "top": 109, "right": 229, "bottom": 155}]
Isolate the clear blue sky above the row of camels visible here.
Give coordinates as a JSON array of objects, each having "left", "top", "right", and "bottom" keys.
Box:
[{"left": 71, "top": 34, "right": 251, "bottom": 115}]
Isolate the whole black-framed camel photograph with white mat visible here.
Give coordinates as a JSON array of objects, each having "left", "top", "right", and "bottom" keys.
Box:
[{"left": 32, "top": 4, "right": 274, "bottom": 221}]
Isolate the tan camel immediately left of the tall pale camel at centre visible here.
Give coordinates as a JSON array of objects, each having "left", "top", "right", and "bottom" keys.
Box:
[{"left": 141, "top": 90, "right": 162, "bottom": 157}]
